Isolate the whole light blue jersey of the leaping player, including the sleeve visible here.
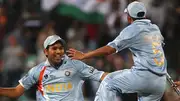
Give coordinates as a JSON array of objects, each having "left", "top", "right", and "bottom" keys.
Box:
[{"left": 108, "top": 19, "right": 167, "bottom": 75}]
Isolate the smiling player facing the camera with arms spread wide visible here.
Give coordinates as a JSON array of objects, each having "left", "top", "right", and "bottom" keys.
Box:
[{"left": 0, "top": 35, "right": 107, "bottom": 101}]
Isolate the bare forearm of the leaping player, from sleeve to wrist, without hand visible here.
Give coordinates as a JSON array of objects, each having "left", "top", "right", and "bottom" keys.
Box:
[{"left": 84, "top": 46, "right": 116, "bottom": 59}]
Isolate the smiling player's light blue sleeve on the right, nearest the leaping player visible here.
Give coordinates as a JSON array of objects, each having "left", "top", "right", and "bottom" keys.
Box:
[{"left": 73, "top": 60, "right": 104, "bottom": 81}]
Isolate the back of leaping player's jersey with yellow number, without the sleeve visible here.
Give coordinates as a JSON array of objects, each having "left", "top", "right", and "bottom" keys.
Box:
[{"left": 130, "top": 20, "right": 166, "bottom": 74}]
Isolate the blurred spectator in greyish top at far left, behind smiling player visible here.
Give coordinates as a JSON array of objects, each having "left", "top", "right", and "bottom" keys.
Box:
[{"left": 2, "top": 35, "right": 25, "bottom": 87}]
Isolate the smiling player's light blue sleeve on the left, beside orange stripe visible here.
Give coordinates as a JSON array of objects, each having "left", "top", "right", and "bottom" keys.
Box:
[{"left": 19, "top": 67, "right": 40, "bottom": 89}]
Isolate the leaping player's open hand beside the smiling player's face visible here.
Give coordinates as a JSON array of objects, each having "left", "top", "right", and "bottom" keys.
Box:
[{"left": 67, "top": 48, "right": 85, "bottom": 60}]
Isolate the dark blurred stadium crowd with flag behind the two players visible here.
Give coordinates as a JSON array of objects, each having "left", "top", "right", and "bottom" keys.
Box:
[{"left": 0, "top": 0, "right": 180, "bottom": 101}]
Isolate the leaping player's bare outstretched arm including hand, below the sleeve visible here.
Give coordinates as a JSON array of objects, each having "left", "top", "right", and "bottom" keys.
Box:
[{"left": 67, "top": 46, "right": 116, "bottom": 60}]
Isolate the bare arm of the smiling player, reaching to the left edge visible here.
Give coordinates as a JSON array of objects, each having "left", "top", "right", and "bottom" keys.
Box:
[{"left": 0, "top": 84, "right": 24, "bottom": 98}]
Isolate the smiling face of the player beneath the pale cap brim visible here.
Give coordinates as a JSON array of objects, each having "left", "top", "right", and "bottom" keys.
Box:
[{"left": 45, "top": 42, "right": 64, "bottom": 65}]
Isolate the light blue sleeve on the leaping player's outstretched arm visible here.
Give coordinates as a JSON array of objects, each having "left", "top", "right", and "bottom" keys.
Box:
[{"left": 107, "top": 26, "right": 138, "bottom": 52}]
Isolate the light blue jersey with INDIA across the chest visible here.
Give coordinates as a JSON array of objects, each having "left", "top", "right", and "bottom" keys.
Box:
[{"left": 19, "top": 56, "right": 104, "bottom": 101}]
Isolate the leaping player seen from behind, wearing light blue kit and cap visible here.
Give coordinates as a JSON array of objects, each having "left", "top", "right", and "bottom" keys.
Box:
[{"left": 68, "top": 1, "right": 167, "bottom": 101}]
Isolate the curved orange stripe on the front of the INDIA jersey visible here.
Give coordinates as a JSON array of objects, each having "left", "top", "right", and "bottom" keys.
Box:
[{"left": 37, "top": 66, "right": 46, "bottom": 95}]
